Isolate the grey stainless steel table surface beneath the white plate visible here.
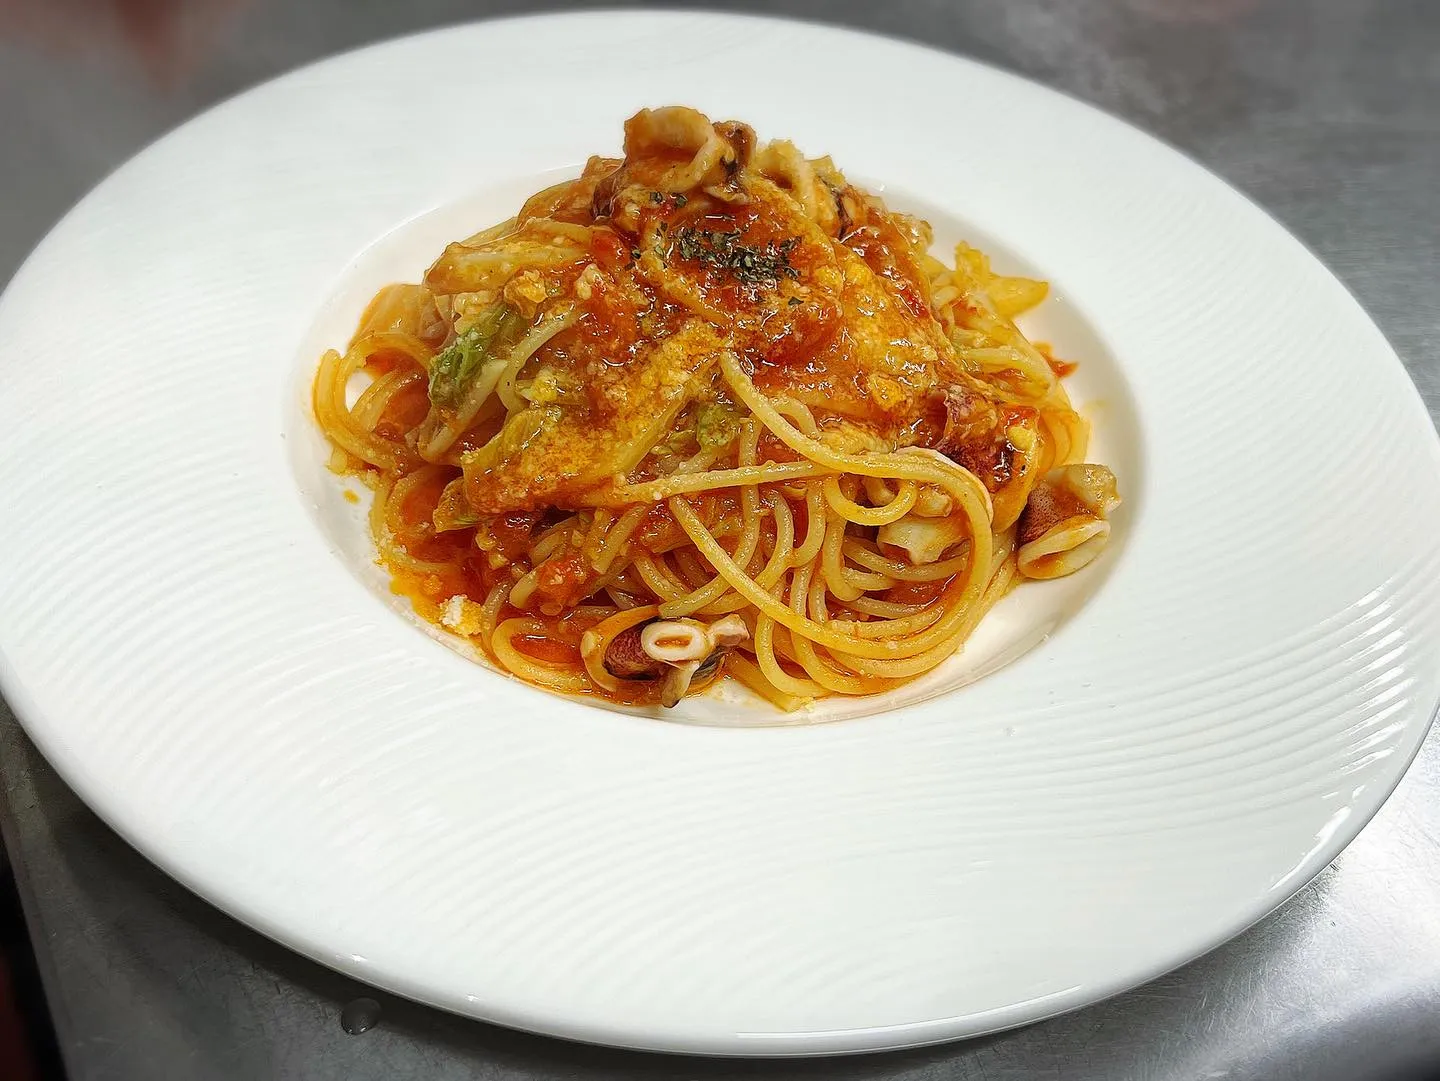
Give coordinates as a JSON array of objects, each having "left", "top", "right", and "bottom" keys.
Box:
[{"left": 0, "top": 0, "right": 1440, "bottom": 1081}]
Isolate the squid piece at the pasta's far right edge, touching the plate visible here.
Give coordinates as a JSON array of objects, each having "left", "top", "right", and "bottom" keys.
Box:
[{"left": 1015, "top": 463, "right": 1120, "bottom": 579}]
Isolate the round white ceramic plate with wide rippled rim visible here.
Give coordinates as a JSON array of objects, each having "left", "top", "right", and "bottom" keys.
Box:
[{"left": 0, "top": 13, "right": 1440, "bottom": 1055}]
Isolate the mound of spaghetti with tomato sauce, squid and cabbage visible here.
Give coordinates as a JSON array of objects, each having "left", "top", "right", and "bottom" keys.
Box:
[{"left": 314, "top": 108, "right": 1119, "bottom": 710}]
